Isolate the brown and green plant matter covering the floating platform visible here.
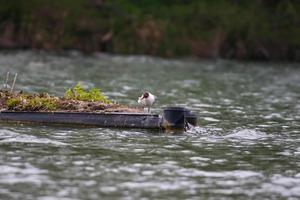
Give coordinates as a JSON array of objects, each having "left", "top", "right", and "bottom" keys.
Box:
[{"left": 0, "top": 84, "right": 143, "bottom": 112}]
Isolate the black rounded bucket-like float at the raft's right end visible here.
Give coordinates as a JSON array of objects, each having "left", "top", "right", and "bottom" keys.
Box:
[{"left": 163, "top": 107, "right": 186, "bottom": 130}]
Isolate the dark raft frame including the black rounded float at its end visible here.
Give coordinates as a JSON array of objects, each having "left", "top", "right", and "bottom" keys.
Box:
[{"left": 0, "top": 107, "right": 197, "bottom": 131}]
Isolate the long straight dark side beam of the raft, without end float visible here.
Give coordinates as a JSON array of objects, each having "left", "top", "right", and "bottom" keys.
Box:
[{"left": 0, "top": 111, "right": 161, "bottom": 129}]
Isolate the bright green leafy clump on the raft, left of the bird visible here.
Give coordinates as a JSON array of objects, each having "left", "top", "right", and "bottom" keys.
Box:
[{"left": 64, "top": 83, "right": 111, "bottom": 104}]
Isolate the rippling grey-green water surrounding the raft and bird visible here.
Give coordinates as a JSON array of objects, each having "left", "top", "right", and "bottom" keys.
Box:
[{"left": 0, "top": 51, "right": 300, "bottom": 200}]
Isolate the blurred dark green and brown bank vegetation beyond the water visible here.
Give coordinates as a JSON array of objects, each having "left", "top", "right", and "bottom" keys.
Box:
[{"left": 0, "top": 0, "right": 300, "bottom": 61}]
